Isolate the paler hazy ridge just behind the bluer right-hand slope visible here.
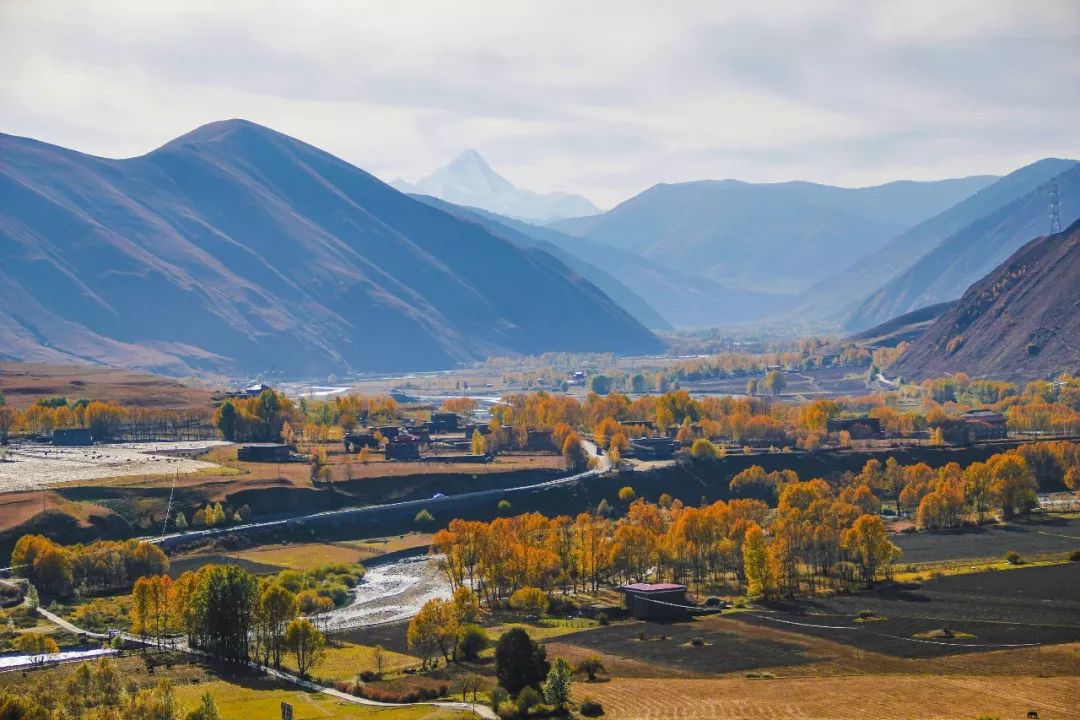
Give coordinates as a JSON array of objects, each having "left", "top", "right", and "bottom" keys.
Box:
[{"left": 792, "top": 158, "right": 1076, "bottom": 327}]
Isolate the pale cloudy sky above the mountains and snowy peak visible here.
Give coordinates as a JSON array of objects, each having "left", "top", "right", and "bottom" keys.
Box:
[{"left": 0, "top": 0, "right": 1080, "bottom": 206}]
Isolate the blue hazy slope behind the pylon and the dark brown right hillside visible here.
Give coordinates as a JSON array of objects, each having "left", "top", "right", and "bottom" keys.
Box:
[{"left": 846, "top": 161, "right": 1080, "bottom": 330}]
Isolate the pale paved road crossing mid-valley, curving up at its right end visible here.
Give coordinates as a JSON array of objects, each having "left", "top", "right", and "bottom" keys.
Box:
[{"left": 141, "top": 440, "right": 611, "bottom": 545}]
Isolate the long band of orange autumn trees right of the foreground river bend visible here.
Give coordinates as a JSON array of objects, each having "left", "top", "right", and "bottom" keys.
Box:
[{"left": 432, "top": 492, "right": 899, "bottom": 604}]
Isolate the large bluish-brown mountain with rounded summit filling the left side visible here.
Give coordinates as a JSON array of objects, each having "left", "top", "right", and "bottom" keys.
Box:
[{"left": 0, "top": 121, "right": 661, "bottom": 375}]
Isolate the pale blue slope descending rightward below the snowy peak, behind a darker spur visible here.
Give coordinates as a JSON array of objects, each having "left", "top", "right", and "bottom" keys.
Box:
[{"left": 408, "top": 195, "right": 789, "bottom": 329}]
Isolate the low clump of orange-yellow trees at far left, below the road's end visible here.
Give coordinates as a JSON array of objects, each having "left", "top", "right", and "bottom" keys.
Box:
[{"left": 11, "top": 535, "right": 168, "bottom": 597}]
